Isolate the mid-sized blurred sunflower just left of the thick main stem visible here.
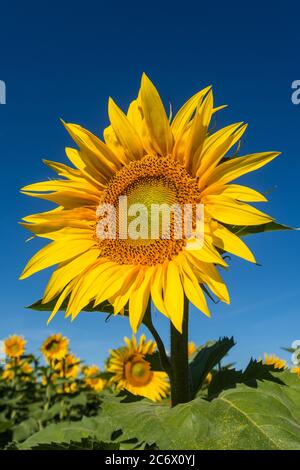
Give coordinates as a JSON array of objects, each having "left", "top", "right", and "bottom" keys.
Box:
[{"left": 107, "top": 335, "right": 170, "bottom": 401}]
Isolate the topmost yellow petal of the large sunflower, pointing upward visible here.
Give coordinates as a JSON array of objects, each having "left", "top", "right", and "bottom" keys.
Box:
[{"left": 140, "top": 74, "right": 173, "bottom": 155}]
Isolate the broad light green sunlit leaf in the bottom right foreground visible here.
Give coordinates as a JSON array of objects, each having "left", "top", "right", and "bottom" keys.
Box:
[{"left": 102, "top": 372, "right": 300, "bottom": 450}]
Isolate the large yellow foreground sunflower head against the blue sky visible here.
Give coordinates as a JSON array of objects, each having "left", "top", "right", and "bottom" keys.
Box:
[{"left": 20, "top": 74, "right": 279, "bottom": 332}]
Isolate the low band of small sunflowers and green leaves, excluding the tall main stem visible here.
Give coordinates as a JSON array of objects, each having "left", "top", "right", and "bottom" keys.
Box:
[{"left": 0, "top": 328, "right": 300, "bottom": 450}]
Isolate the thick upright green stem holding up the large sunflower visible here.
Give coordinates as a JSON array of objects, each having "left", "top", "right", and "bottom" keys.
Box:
[{"left": 171, "top": 298, "right": 191, "bottom": 406}]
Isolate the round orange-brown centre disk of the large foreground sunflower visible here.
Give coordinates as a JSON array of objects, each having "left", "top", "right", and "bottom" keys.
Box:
[{"left": 96, "top": 155, "right": 200, "bottom": 265}]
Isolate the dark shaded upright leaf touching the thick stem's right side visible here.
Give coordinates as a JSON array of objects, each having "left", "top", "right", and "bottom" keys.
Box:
[{"left": 190, "top": 337, "right": 235, "bottom": 397}]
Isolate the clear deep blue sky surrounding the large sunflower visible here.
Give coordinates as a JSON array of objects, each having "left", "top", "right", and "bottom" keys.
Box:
[{"left": 0, "top": 0, "right": 300, "bottom": 366}]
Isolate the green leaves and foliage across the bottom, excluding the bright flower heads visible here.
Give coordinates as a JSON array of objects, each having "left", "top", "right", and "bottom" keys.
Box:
[{"left": 0, "top": 337, "right": 300, "bottom": 450}]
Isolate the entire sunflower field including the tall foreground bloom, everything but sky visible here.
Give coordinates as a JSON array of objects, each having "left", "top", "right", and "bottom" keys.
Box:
[{"left": 0, "top": 74, "right": 300, "bottom": 450}]
